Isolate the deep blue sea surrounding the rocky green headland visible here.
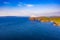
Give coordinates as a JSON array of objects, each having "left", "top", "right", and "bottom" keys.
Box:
[{"left": 0, "top": 17, "right": 60, "bottom": 40}]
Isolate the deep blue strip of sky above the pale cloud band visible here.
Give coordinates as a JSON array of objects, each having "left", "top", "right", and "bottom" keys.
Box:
[{"left": 0, "top": 0, "right": 60, "bottom": 7}]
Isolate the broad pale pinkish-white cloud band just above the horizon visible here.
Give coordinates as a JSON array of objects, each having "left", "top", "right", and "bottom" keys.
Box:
[{"left": 0, "top": 5, "right": 60, "bottom": 16}]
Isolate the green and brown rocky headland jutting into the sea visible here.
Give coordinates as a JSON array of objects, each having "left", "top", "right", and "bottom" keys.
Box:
[{"left": 29, "top": 16, "right": 60, "bottom": 26}]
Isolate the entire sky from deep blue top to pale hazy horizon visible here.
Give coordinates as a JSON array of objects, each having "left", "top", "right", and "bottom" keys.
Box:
[{"left": 0, "top": 0, "right": 60, "bottom": 16}]
